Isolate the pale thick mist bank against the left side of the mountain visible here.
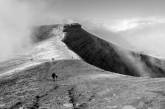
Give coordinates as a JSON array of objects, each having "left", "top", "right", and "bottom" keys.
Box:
[{"left": 0, "top": 0, "right": 32, "bottom": 61}]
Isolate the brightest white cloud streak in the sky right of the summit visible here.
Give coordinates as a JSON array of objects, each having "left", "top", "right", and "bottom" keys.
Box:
[{"left": 104, "top": 17, "right": 165, "bottom": 32}]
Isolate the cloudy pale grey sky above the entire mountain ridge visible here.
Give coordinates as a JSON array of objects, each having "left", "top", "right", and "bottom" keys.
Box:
[{"left": 0, "top": 0, "right": 165, "bottom": 60}]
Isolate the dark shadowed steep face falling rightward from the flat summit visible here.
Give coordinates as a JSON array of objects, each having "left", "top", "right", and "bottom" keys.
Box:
[{"left": 63, "top": 25, "right": 165, "bottom": 77}]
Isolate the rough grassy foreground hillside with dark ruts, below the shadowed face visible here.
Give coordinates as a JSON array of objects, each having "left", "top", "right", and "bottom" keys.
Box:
[{"left": 0, "top": 60, "right": 165, "bottom": 109}]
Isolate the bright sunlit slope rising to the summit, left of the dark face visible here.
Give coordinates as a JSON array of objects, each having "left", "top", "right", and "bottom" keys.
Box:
[{"left": 0, "top": 25, "right": 79, "bottom": 74}]
